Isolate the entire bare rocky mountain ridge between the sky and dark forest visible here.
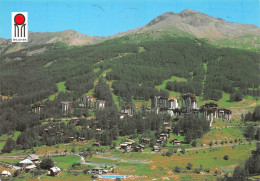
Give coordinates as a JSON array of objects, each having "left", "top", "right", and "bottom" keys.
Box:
[{"left": 0, "top": 9, "right": 260, "bottom": 53}]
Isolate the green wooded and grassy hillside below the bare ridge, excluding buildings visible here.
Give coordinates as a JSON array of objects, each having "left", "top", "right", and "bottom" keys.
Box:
[{"left": 0, "top": 31, "right": 260, "bottom": 180}]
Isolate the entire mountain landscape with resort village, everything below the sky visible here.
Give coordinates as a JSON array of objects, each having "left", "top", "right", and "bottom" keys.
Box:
[{"left": 0, "top": 9, "right": 260, "bottom": 181}]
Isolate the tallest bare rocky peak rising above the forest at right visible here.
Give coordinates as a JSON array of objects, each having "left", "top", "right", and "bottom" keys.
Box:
[{"left": 113, "top": 9, "right": 260, "bottom": 50}]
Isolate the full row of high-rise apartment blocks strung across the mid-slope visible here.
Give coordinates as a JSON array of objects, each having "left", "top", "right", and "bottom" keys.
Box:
[{"left": 32, "top": 93, "right": 232, "bottom": 121}]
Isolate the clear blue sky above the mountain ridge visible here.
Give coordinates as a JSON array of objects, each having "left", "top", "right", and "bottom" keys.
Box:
[{"left": 0, "top": 0, "right": 260, "bottom": 39}]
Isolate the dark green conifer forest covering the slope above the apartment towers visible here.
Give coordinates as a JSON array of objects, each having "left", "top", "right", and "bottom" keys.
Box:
[{"left": 0, "top": 38, "right": 259, "bottom": 103}]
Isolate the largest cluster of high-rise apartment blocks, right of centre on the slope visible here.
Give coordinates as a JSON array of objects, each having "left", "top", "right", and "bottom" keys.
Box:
[{"left": 152, "top": 93, "right": 232, "bottom": 124}]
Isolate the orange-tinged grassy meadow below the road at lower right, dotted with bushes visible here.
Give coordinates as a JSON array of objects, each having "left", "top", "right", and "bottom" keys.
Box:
[{"left": 84, "top": 143, "right": 255, "bottom": 180}]
